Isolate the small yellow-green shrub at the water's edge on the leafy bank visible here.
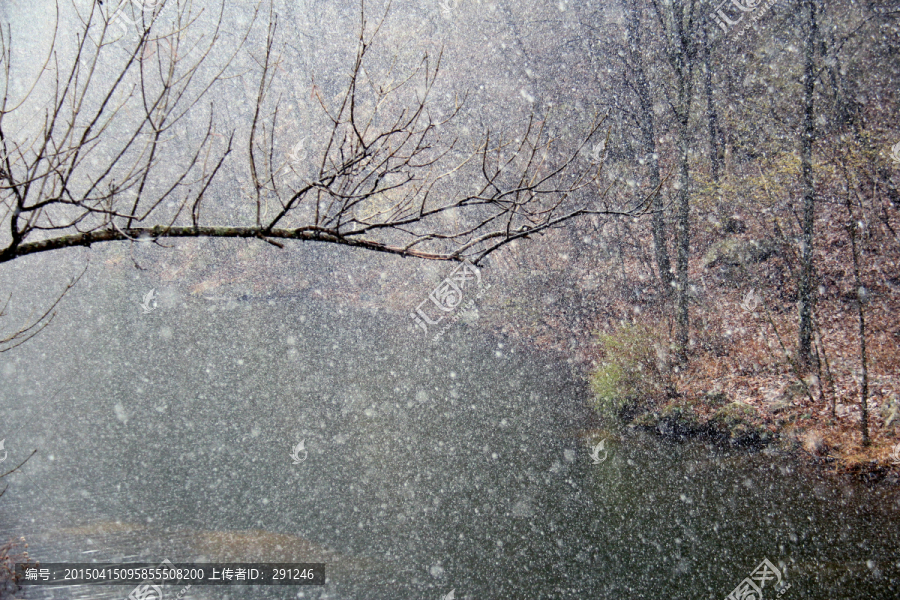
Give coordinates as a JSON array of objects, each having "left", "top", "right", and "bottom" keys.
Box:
[{"left": 590, "top": 325, "right": 668, "bottom": 417}]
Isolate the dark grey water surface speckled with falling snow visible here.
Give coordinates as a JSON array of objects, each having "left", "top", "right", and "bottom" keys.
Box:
[{"left": 0, "top": 288, "right": 900, "bottom": 600}]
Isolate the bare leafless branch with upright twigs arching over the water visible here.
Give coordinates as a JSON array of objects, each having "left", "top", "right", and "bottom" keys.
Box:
[{"left": 0, "top": 0, "right": 647, "bottom": 346}]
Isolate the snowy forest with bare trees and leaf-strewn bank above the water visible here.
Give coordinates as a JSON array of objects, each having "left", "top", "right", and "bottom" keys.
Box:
[{"left": 0, "top": 0, "right": 900, "bottom": 598}]
